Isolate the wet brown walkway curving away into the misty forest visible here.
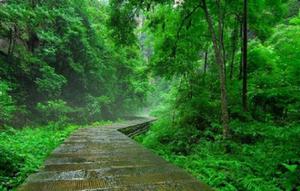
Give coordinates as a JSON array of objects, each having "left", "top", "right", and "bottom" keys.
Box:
[{"left": 18, "top": 120, "right": 211, "bottom": 191}]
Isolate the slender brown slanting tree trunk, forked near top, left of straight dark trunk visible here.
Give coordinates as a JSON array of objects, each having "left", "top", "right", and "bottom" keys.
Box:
[{"left": 200, "top": 0, "right": 230, "bottom": 139}]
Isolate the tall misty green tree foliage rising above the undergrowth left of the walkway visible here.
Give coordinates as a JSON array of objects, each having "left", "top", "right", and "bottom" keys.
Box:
[{"left": 0, "top": 0, "right": 148, "bottom": 125}]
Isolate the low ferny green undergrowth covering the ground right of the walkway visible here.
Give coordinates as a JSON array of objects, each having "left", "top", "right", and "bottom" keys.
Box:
[{"left": 136, "top": 119, "right": 300, "bottom": 191}]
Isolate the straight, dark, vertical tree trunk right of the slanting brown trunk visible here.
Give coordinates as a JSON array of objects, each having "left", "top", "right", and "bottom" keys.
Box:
[{"left": 242, "top": 0, "right": 248, "bottom": 112}]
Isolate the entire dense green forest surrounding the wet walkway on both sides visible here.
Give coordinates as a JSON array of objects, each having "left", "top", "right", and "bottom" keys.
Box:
[{"left": 0, "top": 0, "right": 300, "bottom": 191}]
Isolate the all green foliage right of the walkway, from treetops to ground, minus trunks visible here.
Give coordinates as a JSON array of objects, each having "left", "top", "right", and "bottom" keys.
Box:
[{"left": 136, "top": 0, "right": 300, "bottom": 191}]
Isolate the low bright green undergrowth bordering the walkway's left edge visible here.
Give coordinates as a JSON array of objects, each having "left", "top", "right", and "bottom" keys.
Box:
[{"left": 0, "top": 121, "right": 111, "bottom": 191}]
